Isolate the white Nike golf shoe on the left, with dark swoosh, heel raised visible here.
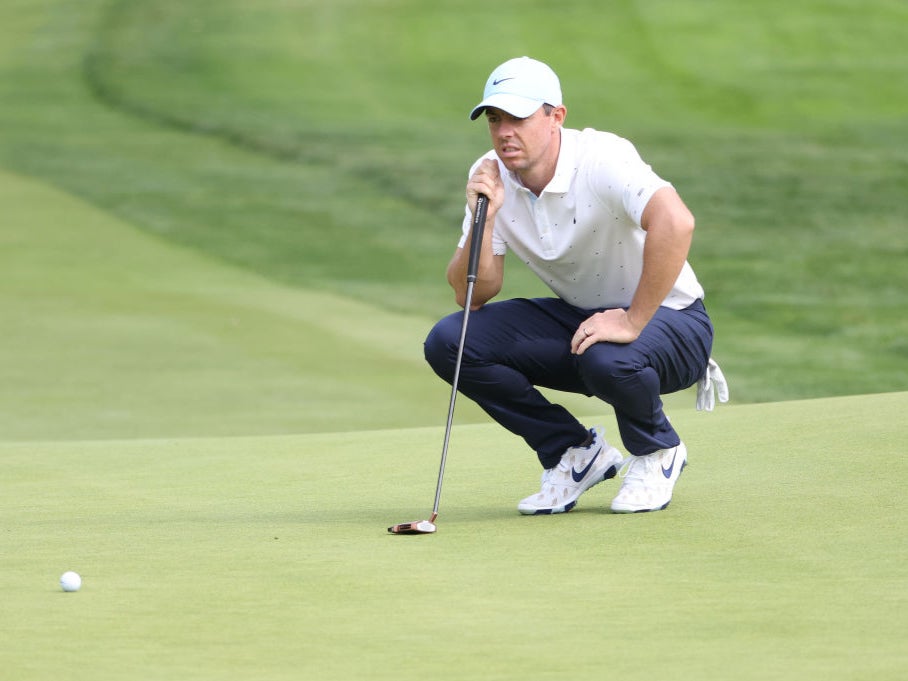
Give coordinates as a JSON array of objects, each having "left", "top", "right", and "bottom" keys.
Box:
[{"left": 517, "top": 428, "right": 624, "bottom": 515}]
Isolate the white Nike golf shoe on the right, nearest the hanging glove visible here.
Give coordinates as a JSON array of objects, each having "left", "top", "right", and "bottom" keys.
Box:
[{"left": 612, "top": 442, "right": 687, "bottom": 513}]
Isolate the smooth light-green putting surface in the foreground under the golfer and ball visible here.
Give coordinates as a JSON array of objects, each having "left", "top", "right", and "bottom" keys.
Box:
[{"left": 0, "top": 393, "right": 908, "bottom": 681}]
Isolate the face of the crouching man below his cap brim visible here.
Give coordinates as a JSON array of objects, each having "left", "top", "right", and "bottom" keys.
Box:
[{"left": 486, "top": 107, "right": 565, "bottom": 174}]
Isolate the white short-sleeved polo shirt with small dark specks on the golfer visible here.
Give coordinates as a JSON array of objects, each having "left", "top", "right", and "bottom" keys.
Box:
[{"left": 460, "top": 128, "right": 703, "bottom": 310}]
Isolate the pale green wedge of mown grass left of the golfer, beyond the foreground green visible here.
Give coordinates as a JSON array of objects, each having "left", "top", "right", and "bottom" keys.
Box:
[{"left": 0, "top": 170, "right": 486, "bottom": 440}]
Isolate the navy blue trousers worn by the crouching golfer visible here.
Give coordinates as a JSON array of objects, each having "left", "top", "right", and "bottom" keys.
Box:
[{"left": 425, "top": 298, "right": 713, "bottom": 468}]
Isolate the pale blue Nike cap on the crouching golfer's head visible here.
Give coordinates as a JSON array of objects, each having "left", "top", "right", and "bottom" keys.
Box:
[{"left": 470, "top": 57, "right": 561, "bottom": 121}]
